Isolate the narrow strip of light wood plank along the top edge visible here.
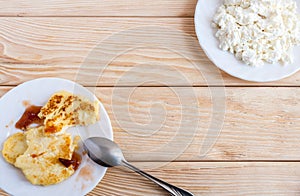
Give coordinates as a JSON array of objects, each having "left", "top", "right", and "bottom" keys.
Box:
[{"left": 0, "top": 0, "right": 197, "bottom": 17}]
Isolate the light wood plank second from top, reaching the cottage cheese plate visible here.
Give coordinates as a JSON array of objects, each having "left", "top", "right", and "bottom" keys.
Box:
[{"left": 0, "top": 17, "right": 300, "bottom": 86}]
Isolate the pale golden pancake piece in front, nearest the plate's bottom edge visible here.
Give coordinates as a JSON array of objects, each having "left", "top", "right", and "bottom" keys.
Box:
[{"left": 14, "top": 127, "right": 78, "bottom": 185}]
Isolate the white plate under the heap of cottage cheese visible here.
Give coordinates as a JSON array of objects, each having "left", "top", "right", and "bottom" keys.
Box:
[{"left": 194, "top": 0, "right": 300, "bottom": 82}]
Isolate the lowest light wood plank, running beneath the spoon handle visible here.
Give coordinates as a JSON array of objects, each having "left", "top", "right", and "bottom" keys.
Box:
[{"left": 0, "top": 162, "right": 300, "bottom": 196}]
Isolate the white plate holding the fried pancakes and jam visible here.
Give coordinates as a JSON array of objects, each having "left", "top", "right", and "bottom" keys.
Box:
[{"left": 0, "top": 78, "right": 113, "bottom": 196}]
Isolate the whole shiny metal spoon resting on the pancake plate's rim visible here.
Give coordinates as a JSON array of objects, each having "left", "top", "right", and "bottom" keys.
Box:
[{"left": 84, "top": 137, "right": 193, "bottom": 196}]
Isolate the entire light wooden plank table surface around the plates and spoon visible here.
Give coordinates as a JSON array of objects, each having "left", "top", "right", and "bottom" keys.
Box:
[{"left": 0, "top": 0, "right": 300, "bottom": 196}]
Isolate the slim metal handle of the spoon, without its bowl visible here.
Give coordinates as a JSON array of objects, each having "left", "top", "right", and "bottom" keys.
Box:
[{"left": 122, "top": 160, "right": 193, "bottom": 196}]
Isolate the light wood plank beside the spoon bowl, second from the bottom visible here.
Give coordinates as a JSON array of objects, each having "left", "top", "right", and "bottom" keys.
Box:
[{"left": 0, "top": 87, "right": 300, "bottom": 161}]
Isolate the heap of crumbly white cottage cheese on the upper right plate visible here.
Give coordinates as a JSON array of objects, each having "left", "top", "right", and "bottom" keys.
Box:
[{"left": 213, "top": 0, "right": 300, "bottom": 66}]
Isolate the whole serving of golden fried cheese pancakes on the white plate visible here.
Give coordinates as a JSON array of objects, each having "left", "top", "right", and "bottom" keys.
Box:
[{"left": 2, "top": 91, "right": 99, "bottom": 186}]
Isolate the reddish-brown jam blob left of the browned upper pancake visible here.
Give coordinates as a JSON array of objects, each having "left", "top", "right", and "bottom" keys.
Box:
[{"left": 15, "top": 105, "right": 44, "bottom": 131}]
